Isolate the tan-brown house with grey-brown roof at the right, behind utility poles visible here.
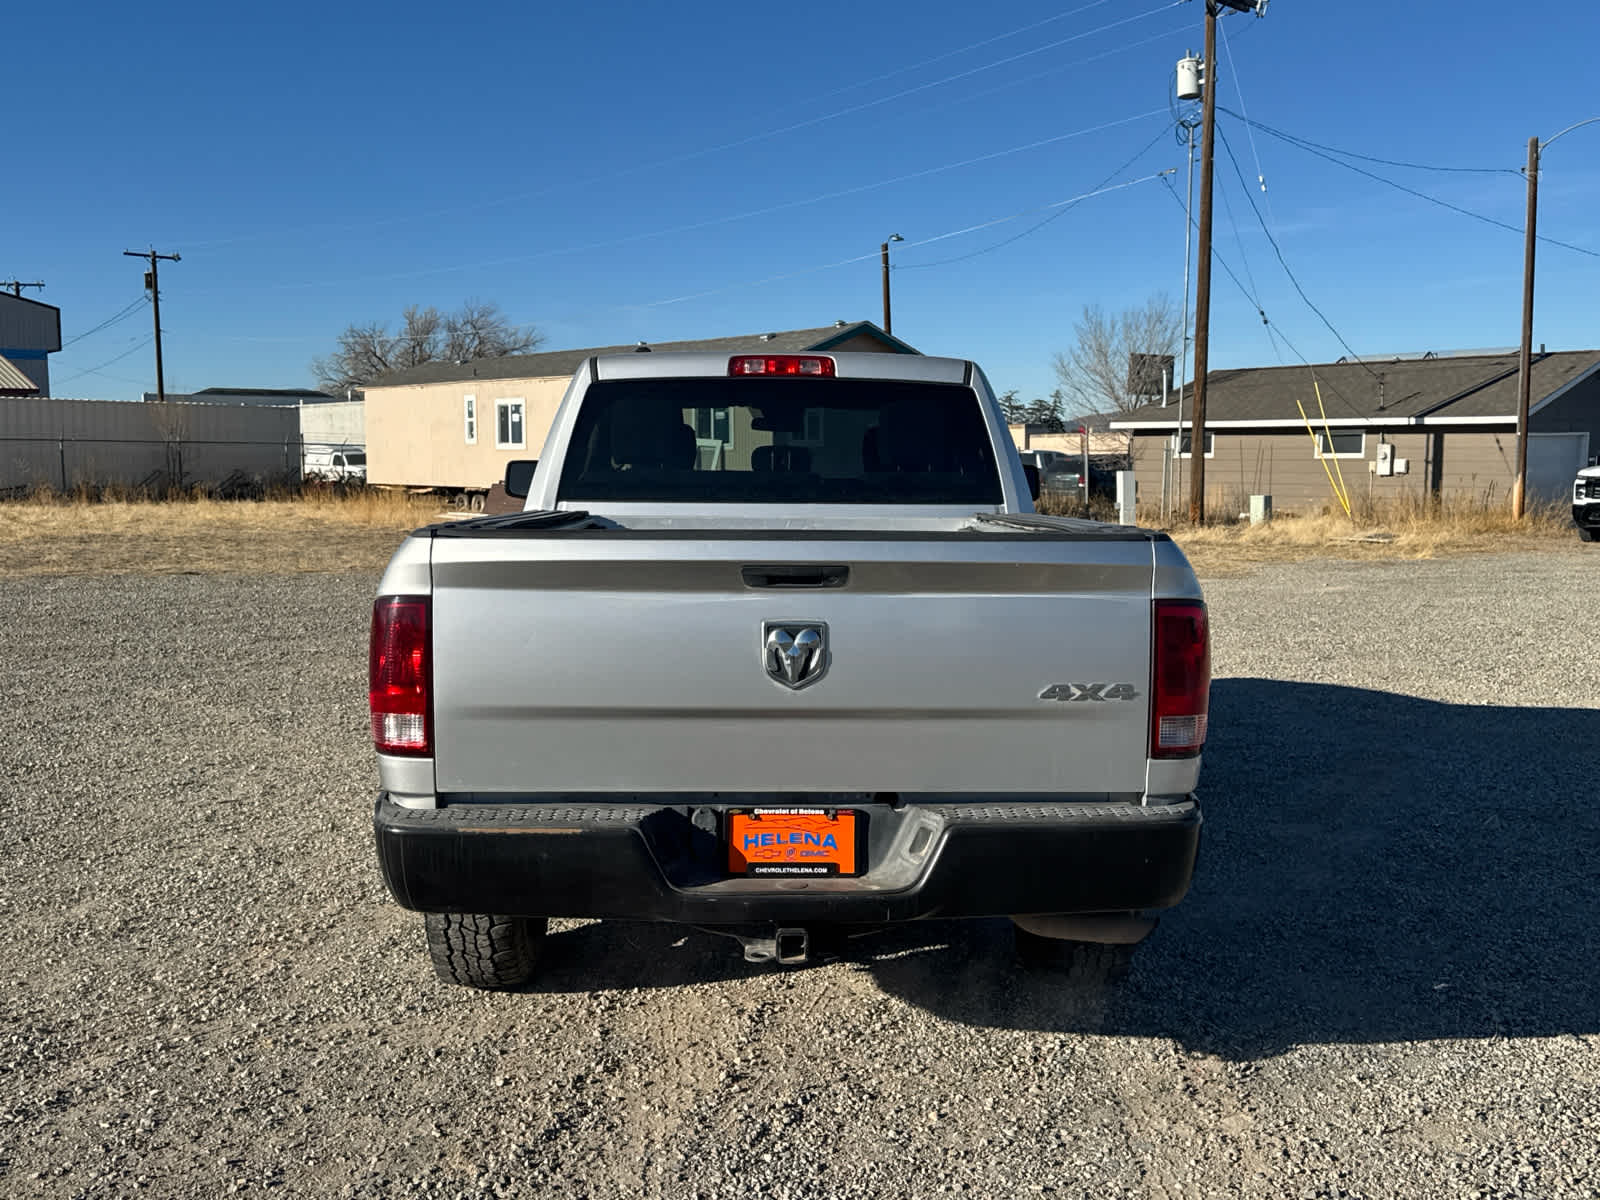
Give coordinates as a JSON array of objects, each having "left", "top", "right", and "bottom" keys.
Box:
[{"left": 1110, "top": 349, "right": 1600, "bottom": 510}]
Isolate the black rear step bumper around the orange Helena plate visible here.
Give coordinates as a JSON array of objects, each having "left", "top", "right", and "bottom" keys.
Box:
[{"left": 373, "top": 795, "right": 1200, "bottom": 925}]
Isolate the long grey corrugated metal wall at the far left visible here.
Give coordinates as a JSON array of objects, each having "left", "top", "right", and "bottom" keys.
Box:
[{"left": 0, "top": 397, "right": 301, "bottom": 491}]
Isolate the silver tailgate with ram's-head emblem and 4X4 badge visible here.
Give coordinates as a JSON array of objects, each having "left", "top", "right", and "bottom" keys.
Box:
[{"left": 432, "top": 531, "right": 1152, "bottom": 797}]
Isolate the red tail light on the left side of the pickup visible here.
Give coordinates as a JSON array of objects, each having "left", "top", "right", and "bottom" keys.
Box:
[{"left": 366, "top": 595, "right": 434, "bottom": 755}]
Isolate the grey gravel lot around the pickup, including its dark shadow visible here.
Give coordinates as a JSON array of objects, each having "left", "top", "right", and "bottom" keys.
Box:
[{"left": 0, "top": 550, "right": 1600, "bottom": 1200}]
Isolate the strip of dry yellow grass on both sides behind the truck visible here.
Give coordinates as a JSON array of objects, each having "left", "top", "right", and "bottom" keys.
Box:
[{"left": 0, "top": 491, "right": 1576, "bottom": 578}]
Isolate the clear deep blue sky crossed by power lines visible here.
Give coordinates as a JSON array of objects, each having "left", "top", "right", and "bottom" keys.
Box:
[{"left": 12, "top": 0, "right": 1600, "bottom": 409}]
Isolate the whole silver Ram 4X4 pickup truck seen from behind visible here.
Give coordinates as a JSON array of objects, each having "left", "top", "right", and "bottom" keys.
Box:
[{"left": 370, "top": 347, "right": 1210, "bottom": 987}]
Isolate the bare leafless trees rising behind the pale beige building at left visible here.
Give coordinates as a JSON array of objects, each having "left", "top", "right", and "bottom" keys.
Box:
[{"left": 310, "top": 299, "right": 544, "bottom": 395}]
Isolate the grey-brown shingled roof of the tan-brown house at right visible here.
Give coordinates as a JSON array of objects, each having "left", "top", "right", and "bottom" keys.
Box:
[{"left": 1117, "top": 350, "right": 1600, "bottom": 429}]
